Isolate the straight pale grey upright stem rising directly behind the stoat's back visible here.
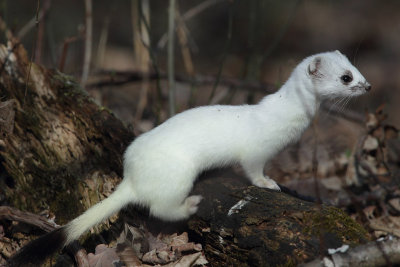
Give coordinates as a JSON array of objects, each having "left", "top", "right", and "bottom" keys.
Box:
[{"left": 167, "top": 0, "right": 176, "bottom": 116}]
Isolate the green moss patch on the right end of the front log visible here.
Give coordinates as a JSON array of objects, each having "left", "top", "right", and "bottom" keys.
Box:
[{"left": 304, "top": 207, "right": 368, "bottom": 245}]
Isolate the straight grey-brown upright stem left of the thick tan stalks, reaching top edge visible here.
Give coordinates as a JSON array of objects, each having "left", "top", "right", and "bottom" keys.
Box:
[{"left": 81, "top": 0, "right": 93, "bottom": 87}]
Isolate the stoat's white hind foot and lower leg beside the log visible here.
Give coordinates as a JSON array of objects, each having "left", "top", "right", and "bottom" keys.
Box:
[{"left": 150, "top": 195, "right": 203, "bottom": 221}]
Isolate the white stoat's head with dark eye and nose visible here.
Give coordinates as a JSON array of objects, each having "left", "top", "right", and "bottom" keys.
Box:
[{"left": 307, "top": 50, "right": 371, "bottom": 99}]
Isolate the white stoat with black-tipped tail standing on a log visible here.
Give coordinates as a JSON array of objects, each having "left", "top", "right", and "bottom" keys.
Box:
[{"left": 9, "top": 51, "right": 371, "bottom": 266}]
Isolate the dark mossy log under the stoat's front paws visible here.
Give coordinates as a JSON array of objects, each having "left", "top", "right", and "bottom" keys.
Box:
[{"left": 188, "top": 174, "right": 368, "bottom": 266}]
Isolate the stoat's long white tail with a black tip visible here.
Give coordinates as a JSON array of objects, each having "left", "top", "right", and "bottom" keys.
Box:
[{"left": 8, "top": 182, "right": 135, "bottom": 266}]
